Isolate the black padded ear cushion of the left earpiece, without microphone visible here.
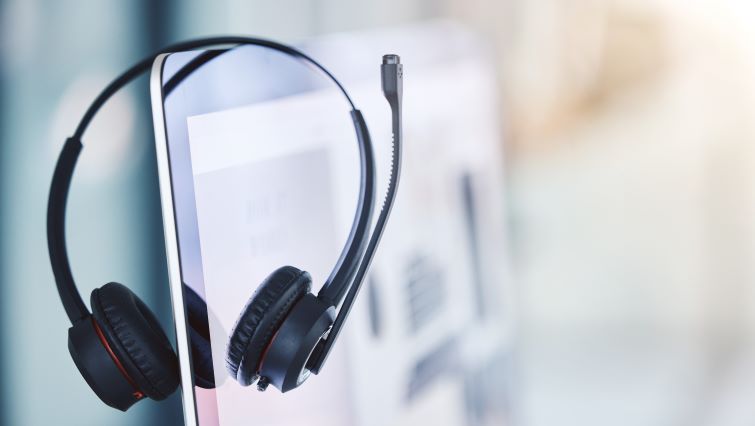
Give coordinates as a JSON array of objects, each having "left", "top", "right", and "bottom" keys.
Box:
[{"left": 91, "top": 283, "right": 179, "bottom": 400}]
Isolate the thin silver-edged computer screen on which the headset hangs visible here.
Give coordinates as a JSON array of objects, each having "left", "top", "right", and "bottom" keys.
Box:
[{"left": 151, "top": 24, "right": 513, "bottom": 426}]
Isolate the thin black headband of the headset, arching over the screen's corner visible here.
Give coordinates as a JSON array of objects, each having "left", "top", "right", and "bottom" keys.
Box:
[{"left": 47, "top": 37, "right": 378, "bottom": 324}]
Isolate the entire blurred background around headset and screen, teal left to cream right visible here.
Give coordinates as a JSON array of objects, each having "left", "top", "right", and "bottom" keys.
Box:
[{"left": 0, "top": 0, "right": 755, "bottom": 426}]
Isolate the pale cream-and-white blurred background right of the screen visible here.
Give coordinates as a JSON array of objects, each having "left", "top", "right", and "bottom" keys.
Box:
[{"left": 452, "top": 0, "right": 755, "bottom": 425}]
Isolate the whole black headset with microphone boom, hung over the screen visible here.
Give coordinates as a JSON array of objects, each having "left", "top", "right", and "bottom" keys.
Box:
[{"left": 47, "top": 36, "right": 403, "bottom": 411}]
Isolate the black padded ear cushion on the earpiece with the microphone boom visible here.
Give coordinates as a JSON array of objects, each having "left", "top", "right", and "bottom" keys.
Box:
[{"left": 226, "top": 266, "right": 312, "bottom": 386}]
